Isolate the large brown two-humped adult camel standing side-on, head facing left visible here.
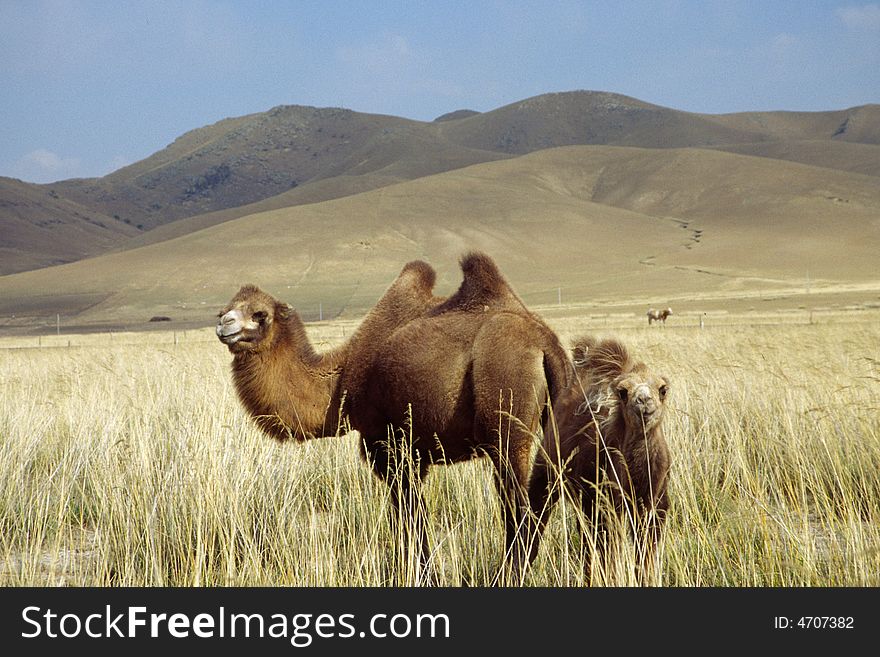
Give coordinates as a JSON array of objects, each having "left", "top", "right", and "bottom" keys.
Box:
[{"left": 217, "top": 253, "right": 571, "bottom": 578}]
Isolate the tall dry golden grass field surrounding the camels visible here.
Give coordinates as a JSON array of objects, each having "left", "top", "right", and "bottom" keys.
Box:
[{"left": 0, "top": 310, "right": 880, "bottom": 586}]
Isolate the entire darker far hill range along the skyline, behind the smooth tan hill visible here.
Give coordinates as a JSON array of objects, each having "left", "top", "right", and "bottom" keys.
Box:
[{"left": 0, "top": 91, "right": 880, "bottom": 275}]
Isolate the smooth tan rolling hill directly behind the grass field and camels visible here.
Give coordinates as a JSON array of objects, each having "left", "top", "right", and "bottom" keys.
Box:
[{"left": 0, "top": 142, "right": 880, "bottom": 328}]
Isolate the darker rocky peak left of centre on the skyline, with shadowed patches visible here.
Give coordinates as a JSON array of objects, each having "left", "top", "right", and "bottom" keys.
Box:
[{"left": 57, "top": 106, "right": 508, "bottom": 228}]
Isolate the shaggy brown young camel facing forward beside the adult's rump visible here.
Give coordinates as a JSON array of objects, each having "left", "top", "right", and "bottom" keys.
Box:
[{"left": 529, "top": 337, "right": 669, "bottom": 581}]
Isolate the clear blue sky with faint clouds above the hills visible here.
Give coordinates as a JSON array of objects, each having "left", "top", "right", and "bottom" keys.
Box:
[{"left": 0, "top": 0, "right": 880, "bottom": 182}]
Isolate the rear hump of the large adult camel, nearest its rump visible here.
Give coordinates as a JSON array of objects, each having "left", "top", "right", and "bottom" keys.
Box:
[{"left": 430, "top": 251, "right": 525, "bottom": 315}]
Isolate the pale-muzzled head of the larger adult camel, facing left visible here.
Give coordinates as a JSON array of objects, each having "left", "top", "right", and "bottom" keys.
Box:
[{"left": 216, "top": 285, "right": 293, "bottom": 354}]
